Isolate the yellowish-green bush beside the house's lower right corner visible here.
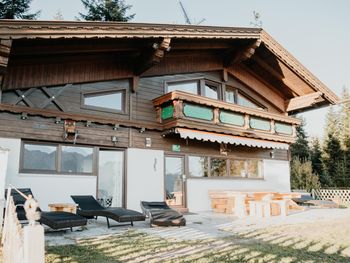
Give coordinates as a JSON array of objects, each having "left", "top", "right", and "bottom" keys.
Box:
[{"left": 291, "top": 158, "right": 320, "bottom": 191}]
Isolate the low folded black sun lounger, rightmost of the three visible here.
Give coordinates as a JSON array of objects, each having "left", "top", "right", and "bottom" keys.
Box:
[{"left": 141, "top": 201, "right": 186, "bottom": 227}]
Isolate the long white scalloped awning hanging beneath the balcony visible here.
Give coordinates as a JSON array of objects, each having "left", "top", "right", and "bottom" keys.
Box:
[{"left": 175, "top": 128, "right": 289, "bottom": 150}]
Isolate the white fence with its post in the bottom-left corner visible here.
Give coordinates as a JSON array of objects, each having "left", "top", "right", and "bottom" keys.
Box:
[{"left": 1, "top": 189, "right": 45, "bottom": 263}]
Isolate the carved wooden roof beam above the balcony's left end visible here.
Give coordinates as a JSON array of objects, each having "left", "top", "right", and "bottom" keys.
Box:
[{"left": 134, "top": 38, "right": 171, "bottom": 76}]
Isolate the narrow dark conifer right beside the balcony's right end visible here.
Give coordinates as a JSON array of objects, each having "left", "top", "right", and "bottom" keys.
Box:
[{"left": 291, "top": 119, "right": 310, "bottom": 161}]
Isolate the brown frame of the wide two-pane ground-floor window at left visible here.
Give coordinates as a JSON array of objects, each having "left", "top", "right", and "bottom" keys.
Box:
[{"left": 19, "top": 140, "right": 98, "bottom": 176}]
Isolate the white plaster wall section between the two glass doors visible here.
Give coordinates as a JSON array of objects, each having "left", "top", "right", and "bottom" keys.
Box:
[{"left": 126, "top": 148, "right": 164, "bottom": 211}]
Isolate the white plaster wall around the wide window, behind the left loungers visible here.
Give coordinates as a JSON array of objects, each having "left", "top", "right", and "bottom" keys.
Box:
[{"left": 0, "top": 138, "right": 96, "bottom": 210}]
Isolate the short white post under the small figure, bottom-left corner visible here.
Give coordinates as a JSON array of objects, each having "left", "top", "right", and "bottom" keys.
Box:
[{"left": 23, "top": 225, "right": 45, "bottom": 263}]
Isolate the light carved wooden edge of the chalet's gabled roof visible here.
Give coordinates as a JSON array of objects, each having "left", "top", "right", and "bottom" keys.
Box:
[{"left": 0, "top": 20, "right": 339, "bottom": 109}]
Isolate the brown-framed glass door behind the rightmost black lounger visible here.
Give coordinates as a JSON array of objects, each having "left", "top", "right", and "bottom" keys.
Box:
[{"left": 165, "top": 156, "right": 186, "bottom": 208}]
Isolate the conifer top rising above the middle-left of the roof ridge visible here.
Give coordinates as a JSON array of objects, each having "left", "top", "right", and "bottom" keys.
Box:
[{"left": 79, "top": 0, "right": 135, "bottom": 22}]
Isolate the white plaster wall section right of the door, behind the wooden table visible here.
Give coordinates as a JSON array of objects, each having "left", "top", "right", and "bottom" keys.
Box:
[{"left": 187, "top": 160, "right": 290, "bottom": 212}]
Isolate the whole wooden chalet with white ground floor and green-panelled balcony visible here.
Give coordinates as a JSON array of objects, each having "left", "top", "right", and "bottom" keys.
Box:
[{"left": 0, "top": 20, "right": 338, "bottom": 211}]
